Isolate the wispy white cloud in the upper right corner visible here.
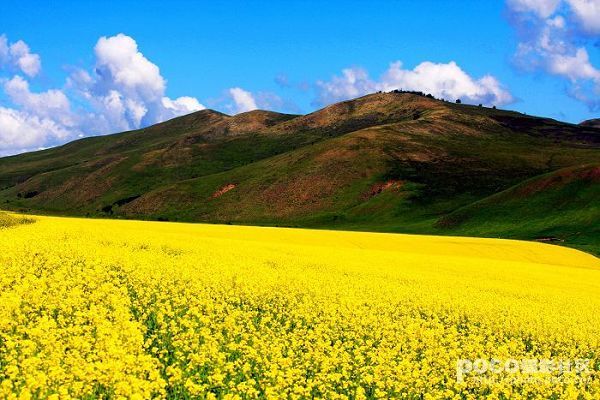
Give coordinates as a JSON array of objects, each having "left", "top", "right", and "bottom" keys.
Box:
[{"left": 507, "top": 0, "right": 600, "bottom": 110}]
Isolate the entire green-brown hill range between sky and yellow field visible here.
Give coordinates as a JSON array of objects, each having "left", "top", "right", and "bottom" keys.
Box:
[{"left": 0, "top": 93, "right": 600, "bottom": 252}]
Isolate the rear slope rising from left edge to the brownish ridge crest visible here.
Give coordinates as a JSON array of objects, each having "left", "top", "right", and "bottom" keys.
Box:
[{"left": 0, "top": 93, "right": 432, "bottom": 214}]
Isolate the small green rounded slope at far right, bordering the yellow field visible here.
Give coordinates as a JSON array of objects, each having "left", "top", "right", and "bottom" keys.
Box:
[{"left": 437, "top": 165, "right": 600, "bottom": 254}]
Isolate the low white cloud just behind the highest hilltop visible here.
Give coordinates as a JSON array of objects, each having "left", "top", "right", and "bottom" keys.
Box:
[{"left": 314, "top": 61, "right": 513, "bottom": 105}]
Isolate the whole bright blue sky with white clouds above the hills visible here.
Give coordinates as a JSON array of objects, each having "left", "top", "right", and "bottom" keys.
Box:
[{"left": 0, "top": 0, "right": 600, "bottom": 154}]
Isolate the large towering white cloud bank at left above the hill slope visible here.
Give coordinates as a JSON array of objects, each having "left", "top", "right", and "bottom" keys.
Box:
[{"left": 0, "top": 34, "right": 204, "bottom": 155}]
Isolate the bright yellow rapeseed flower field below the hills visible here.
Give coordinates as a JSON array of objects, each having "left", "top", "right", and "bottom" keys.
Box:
[{"left": 0, "top": 217, "right": 600, "bottom": 399}]
